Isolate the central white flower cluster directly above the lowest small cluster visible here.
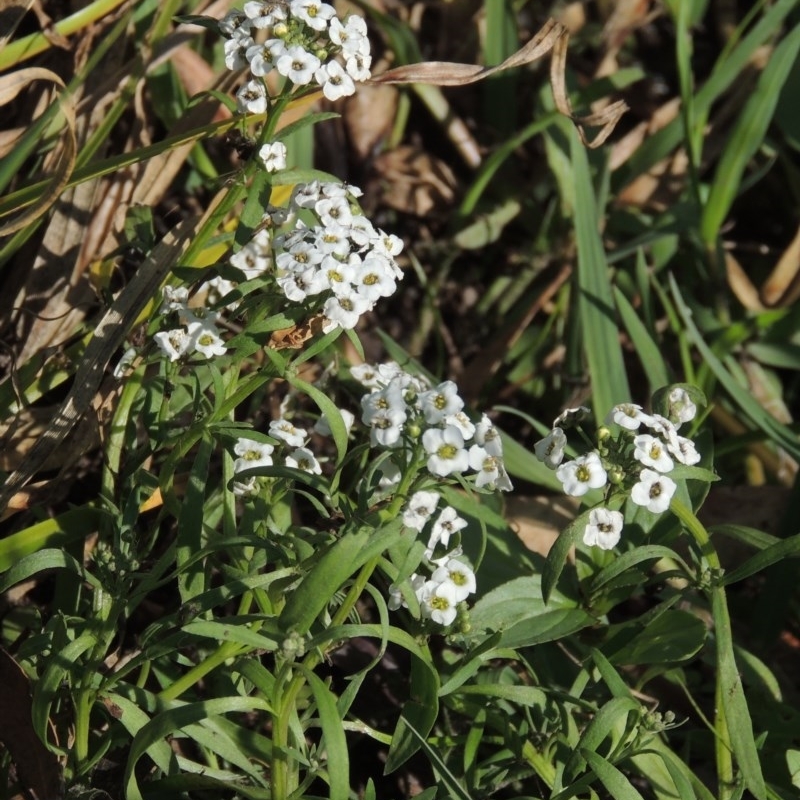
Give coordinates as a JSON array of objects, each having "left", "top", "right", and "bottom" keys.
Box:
[{"left": 351, "top": 363, "right": 512, "bottom": 491}]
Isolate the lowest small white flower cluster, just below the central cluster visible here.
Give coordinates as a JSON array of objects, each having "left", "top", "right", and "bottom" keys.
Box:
[{"left": 389, "top": 491, "right": 476, "bottom": 625}]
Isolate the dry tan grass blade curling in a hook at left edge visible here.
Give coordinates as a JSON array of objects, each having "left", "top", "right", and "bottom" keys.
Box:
[{"left": 0, "top": 67, "right": 78, "bottom": 236}]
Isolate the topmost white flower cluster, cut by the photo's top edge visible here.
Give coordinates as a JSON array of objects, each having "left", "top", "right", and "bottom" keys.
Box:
[{"left": 219, "top": 0, "right": 372, "bottom": 114}]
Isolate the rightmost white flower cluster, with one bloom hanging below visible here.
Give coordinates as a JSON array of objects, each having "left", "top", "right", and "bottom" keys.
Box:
[{"left": 534, "top": 386, "right": 700, "bottom": 550}]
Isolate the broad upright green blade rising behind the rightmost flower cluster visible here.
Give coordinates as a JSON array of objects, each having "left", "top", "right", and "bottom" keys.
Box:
[{"left": 563, "top": 126, "right": 630, "bottom": 424}]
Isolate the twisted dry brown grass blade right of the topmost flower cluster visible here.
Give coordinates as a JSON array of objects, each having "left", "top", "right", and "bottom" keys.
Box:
[{"left": 372, "top": 19, "right": 628, "bottom": 148}]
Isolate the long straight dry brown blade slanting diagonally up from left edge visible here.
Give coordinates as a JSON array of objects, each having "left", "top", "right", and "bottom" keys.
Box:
[{"left": 0, "top": 206, "right": 217, "bottom": 510}]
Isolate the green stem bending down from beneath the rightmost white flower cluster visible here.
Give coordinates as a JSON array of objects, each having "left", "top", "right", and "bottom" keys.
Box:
[{"left": 670, "top": 498, "right": 734, "bottom": 800}]
